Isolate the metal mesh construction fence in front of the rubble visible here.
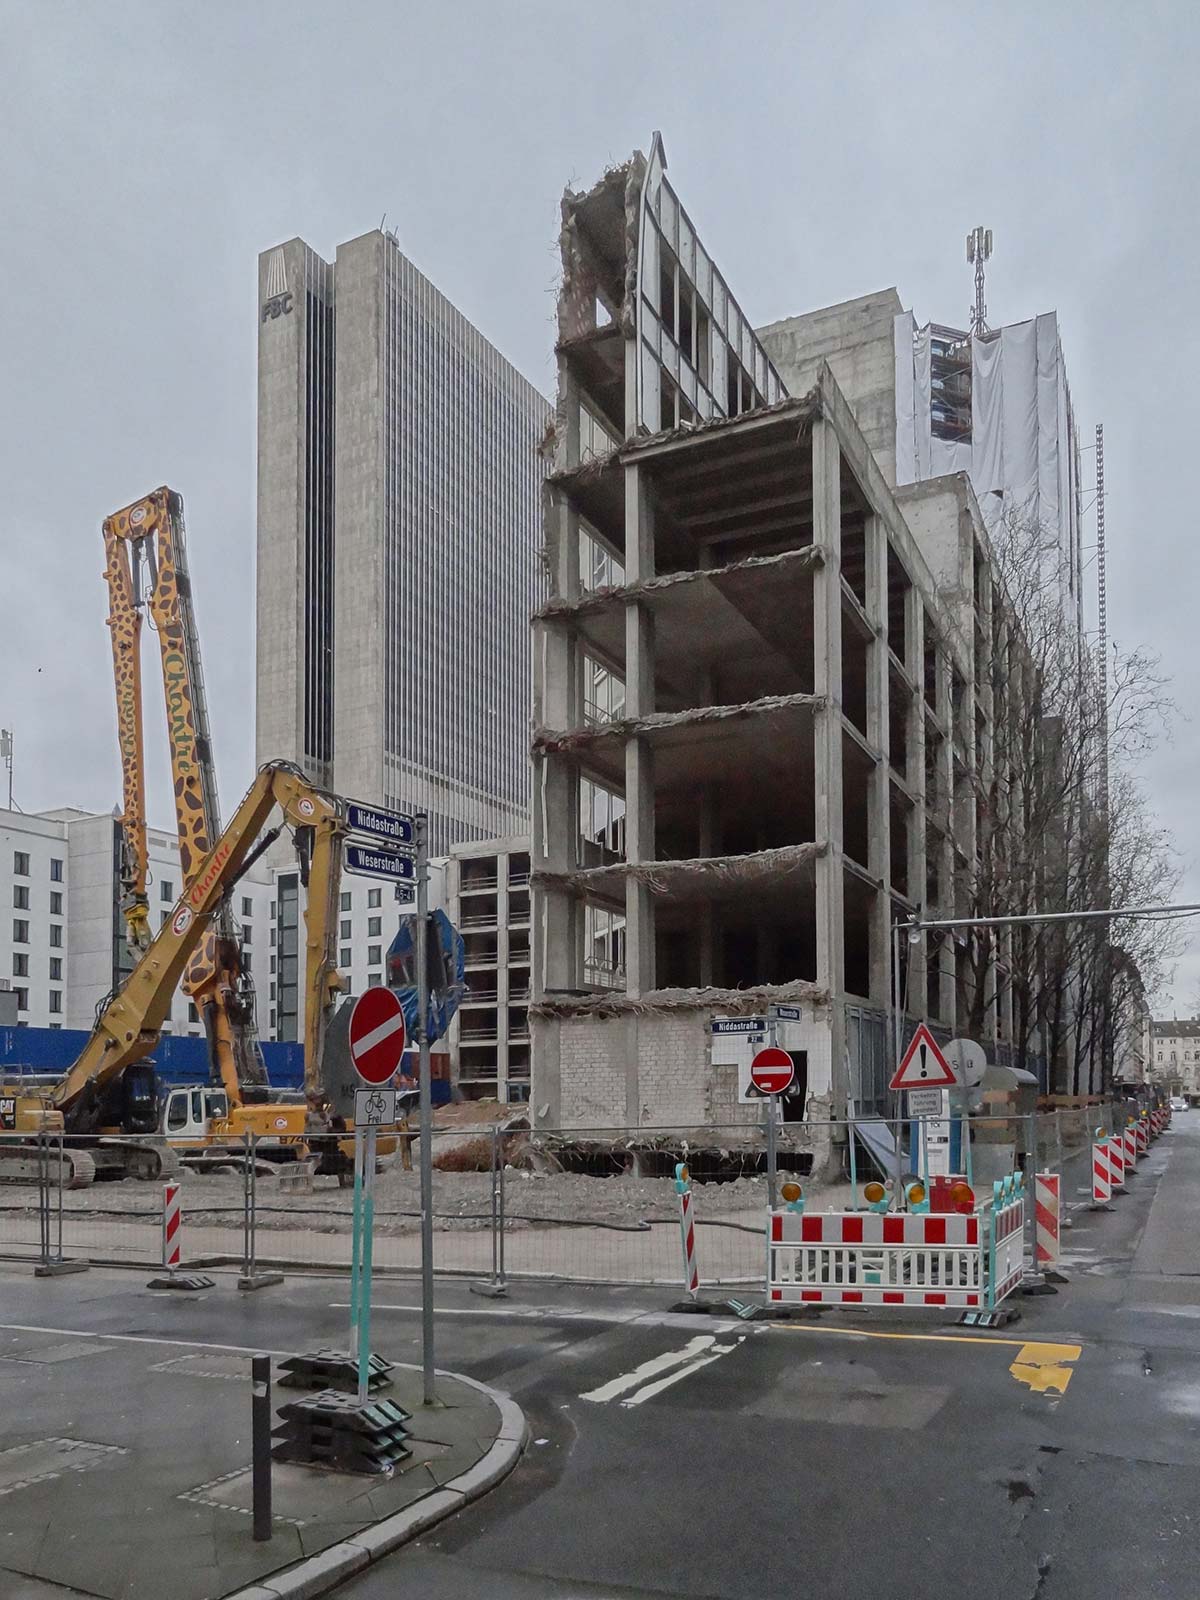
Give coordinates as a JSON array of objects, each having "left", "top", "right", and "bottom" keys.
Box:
[{"left": 0, "top": 1106, "right": 1139, "bottom": 1285}]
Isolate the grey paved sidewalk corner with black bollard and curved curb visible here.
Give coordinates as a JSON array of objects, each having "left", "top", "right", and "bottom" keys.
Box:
[{"left": 0, "top": 1331, "right": 525, "bottom": 1600}]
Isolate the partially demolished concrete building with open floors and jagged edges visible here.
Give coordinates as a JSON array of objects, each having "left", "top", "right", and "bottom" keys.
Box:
[{"left": 531, "top": 136, "right": 1036, "bottom": 1128}]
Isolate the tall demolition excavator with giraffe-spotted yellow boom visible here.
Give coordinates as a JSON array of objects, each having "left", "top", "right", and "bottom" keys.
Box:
[{"left": 104, "top": 486, "right": 306, "bottom": 1157}]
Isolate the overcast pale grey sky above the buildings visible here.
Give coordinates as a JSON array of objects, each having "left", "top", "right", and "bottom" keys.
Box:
[{"left": 0, "top": 0, "right": 1200, "bottom": 1006}]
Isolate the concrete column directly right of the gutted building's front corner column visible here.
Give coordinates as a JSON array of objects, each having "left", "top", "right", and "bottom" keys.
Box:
[{"left": 866, "top": 517, "right": 891, "bottom": 1006}]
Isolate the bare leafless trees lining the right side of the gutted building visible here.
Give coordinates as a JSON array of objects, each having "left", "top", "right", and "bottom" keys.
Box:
[{"left": 957, "top": 517, "right": 1179, "bottom": 1093}]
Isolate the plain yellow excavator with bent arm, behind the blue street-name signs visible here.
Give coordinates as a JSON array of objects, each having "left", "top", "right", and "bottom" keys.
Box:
[{"left": 0, "top": 762, "right": 347, "bottom": 1189}]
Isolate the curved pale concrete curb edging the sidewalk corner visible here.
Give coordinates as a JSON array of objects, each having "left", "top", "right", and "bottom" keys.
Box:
[{"left": 226, "top": 1363, "right": 530, "bottom": 1600}]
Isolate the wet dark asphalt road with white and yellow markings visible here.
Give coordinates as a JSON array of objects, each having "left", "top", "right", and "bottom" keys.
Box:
[{"left": 0, "top": 1112, "right": 1200, "bottom": 1600}]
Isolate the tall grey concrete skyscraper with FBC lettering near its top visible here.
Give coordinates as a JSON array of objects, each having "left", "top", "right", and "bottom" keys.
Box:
[{"left": 256, "top": 230, "right": 552, "bottom": 854}]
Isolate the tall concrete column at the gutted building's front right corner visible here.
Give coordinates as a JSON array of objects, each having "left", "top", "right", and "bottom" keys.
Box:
[{"left": 813, "top": 418, "right": 850, "bottom": 1107}]
